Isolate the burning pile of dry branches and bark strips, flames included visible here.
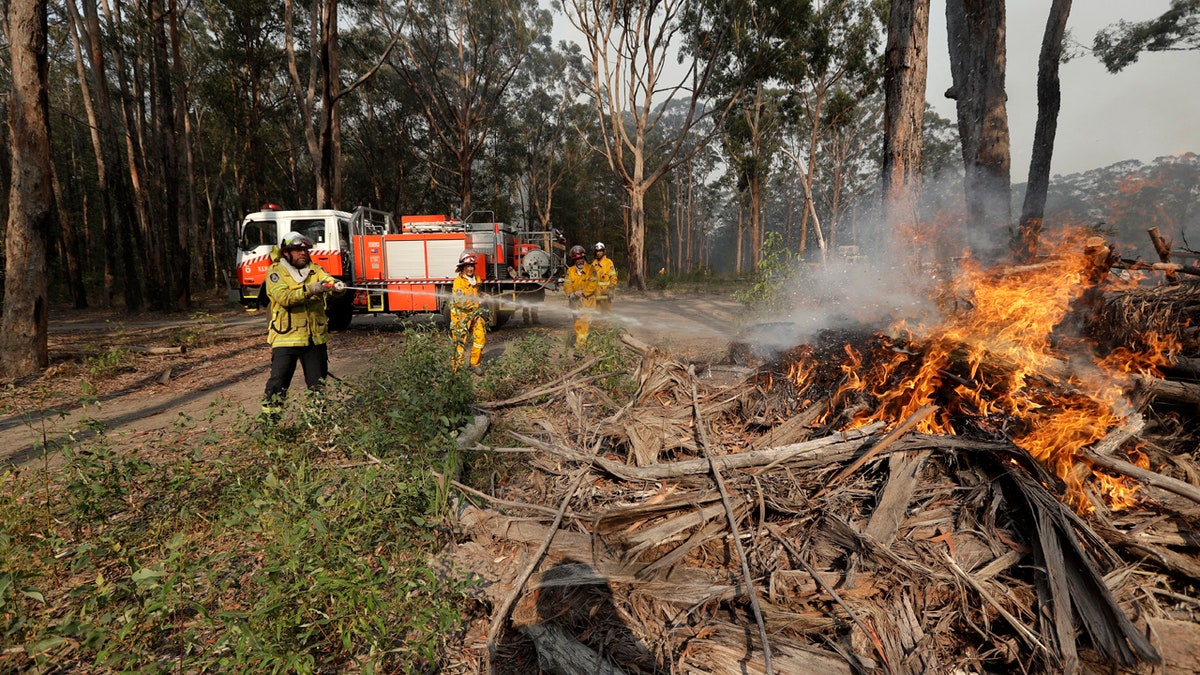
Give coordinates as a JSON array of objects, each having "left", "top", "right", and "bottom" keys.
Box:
[{"left": 452, "top": 233, "right": 1200, "bottom": 674}]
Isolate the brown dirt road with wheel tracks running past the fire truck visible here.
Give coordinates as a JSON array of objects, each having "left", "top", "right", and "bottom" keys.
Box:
[{"left": 0, "top": 293, "right": 740, "bottom": 464}]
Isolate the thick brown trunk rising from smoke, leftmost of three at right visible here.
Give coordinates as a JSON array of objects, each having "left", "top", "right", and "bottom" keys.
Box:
[{"left": 878, "top": 0, "right": 929, "bottom": 245}]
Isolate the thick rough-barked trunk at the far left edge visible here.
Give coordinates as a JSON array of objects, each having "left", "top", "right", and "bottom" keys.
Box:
[{"left": 0, "top": 0, "right": 52, "bottom": 377}]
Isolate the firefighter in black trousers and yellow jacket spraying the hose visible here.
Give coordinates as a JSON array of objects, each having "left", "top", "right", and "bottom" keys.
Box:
[{"left": 256, "top": 232, "right": 346, "bottom": 423}]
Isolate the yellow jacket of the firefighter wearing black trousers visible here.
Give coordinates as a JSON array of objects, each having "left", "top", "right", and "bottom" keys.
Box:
[{"left": 266, "top": 256, "right": 337, "bottom": 347}]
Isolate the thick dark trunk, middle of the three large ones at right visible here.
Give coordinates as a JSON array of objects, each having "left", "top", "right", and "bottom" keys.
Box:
[{"left": 946, "top": 0, "right": 1013, "bottom": 261}]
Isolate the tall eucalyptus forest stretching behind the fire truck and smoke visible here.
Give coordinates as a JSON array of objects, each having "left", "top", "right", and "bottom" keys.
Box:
[{"left": 0, "top": 0, "right": 1200, "bottom": 372}]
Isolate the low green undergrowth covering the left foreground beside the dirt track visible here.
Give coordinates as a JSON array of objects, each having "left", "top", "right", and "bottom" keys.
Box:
[{"left": 0, "top": 331, "right": 470, "bottom": 673}]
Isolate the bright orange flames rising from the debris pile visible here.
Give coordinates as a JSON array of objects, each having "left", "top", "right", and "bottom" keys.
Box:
[{"left": 811, "top": 231, "right": 1178, "bottom": 512}]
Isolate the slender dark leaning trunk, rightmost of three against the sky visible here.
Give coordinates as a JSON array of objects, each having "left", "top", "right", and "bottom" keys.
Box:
[{"left": 1016, "top": 0, "right": 1070, "bottom": 259}]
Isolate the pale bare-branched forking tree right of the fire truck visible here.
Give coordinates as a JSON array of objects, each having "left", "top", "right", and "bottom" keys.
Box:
[{"left": 563, "top": 0, "right": 732, "bottom": 289}]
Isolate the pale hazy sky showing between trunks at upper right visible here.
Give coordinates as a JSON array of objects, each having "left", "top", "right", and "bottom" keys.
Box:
[{"left": 925, "top": 0, "right": 1200, "bottom": 176}]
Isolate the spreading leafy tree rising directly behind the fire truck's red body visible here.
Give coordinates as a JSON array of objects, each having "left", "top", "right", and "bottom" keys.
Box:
[{"left": 388, "top": 0, "right": 552, "bottom": 215}]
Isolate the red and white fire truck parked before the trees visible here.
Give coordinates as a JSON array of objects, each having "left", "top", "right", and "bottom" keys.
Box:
[{"left": 229, "top": 204, "right": 565, "bottom": 330}]
